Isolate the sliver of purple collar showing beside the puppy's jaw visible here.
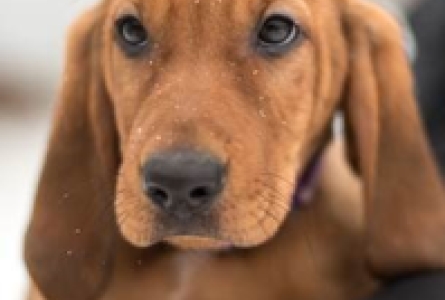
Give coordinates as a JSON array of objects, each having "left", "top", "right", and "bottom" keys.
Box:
[{"left": 293, "top": 151, "right": 323, "bottom": 210}]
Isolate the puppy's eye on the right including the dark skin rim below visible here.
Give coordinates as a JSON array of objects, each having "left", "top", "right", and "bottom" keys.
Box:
[{"left": 257, "top": 15, "right": 303, "bottom": 54}]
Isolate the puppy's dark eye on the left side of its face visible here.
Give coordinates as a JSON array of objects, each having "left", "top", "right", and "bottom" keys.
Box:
[{"left": 116, "top": 15, "right": 148, "bottom": 56}]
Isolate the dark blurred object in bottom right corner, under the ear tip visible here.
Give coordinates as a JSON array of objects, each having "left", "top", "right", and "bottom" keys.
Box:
[{"left": 367, "top": 272, "right": 445, "bottom": 300}]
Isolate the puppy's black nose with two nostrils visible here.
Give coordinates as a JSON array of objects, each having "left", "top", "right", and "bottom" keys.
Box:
[{"left": 143, "top": 150, "right": 225, "bottom": 218}]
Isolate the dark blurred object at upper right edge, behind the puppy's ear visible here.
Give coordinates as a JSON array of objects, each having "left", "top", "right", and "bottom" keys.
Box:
[{"left": 410, "top": 0, "right": 445, "bottom": 176}]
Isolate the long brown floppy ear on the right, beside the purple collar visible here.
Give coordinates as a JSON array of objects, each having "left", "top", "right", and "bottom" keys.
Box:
[{"left": 344, "top": 0, "right": 445, "bottom": 276}]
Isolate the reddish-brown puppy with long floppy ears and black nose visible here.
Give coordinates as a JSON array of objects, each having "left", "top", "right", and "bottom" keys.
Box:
[{"left": 25, "top": 0, "right": 445, "bottom": 300}]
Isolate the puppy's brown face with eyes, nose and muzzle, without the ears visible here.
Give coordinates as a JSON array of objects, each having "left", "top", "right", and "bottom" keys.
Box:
[{"left": 101, "top": 0, "right": 346, "bottom": 248}]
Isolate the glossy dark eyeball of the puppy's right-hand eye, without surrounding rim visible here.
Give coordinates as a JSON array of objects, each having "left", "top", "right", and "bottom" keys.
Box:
[{"left": 259, "top": 16, "right": 297, "bottom": 44}]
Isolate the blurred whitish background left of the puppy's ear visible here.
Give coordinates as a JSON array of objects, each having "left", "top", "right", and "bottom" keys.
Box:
[{"left": 0, "top": 0, "right": 95, "bottom": 300}]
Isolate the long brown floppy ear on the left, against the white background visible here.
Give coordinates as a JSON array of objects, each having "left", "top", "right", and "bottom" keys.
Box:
[{"left": 25, "top": 8, "right": 118, "bottom": 300}]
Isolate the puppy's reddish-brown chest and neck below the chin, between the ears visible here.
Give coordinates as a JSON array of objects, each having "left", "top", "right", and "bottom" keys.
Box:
[{"left": 101, "top": 195, "right": 375, "bottom": 300}]
